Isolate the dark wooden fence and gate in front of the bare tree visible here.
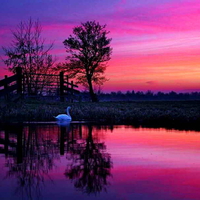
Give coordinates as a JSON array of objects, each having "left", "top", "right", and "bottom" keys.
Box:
[{"left": 0, "top": 67, "right": 80, "bottom": 102}]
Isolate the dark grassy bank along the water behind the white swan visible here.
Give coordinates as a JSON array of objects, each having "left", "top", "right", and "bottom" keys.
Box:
[{"left": 0, "top": 100, "right": 200, "bottom": 130}]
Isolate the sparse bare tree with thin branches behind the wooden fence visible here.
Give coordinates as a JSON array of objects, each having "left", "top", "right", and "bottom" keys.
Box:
[{"left": 2, "top": 18, "right": 55, "bottom": 94}]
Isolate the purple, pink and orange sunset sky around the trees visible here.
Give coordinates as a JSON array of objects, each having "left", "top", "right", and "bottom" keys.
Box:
[{"left": 0, "top": 0, "right": 200, "bottom": 92}]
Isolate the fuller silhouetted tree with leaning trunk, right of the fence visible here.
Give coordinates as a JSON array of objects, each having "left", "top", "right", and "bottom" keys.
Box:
[{"left": 62, "top": 21, "right": 112, "bottom": 102}]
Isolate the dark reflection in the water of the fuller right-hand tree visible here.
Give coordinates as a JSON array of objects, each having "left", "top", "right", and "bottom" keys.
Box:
[{"left": 65, "top": 126, "right": 112, "bottom": 194}]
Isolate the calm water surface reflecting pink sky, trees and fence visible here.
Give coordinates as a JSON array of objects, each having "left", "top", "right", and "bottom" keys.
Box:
[{"left": 0, "top": 124, "right": 200, "bottom": 200}]
